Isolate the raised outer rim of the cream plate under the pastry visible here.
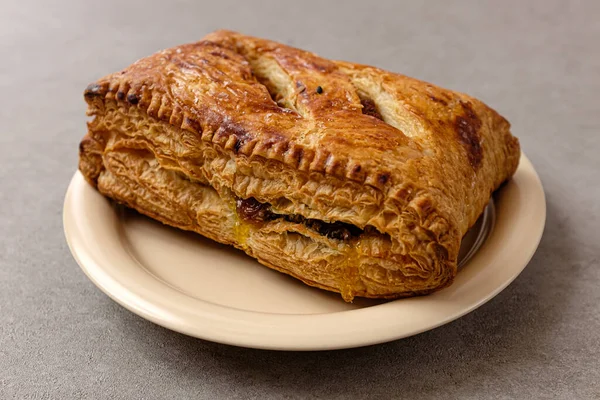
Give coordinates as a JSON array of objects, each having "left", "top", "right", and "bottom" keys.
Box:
[{"left": 63, "top": 154, "right": 546, "bottom": 351}]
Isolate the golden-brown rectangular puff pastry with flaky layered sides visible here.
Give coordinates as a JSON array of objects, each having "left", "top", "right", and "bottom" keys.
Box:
[{"left": 79, "top": 31, "right": 520, "bottom": 301}]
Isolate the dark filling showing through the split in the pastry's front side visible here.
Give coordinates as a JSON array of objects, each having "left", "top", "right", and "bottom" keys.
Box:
[{"left": 236, "top": 197, "right": 364, "bottom": 241}]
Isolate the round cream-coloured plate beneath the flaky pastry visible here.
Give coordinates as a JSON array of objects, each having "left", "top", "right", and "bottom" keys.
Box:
[{"left": 64, "top": 156, "right": 546, "bottom": 350}]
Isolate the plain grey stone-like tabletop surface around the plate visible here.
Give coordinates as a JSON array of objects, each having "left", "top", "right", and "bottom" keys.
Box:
[{"left": 0, "top": 0, "right": 600, "bottom": 399}]
